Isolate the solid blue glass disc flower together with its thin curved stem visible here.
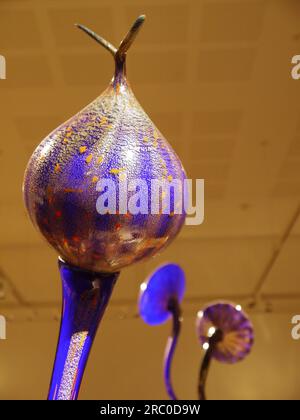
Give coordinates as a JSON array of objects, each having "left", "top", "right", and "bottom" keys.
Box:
[{"left": 139, "top": 264, "right": 185, "bottom": 400}]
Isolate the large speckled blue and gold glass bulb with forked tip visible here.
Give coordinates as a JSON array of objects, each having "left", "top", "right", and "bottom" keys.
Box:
[{"left": 24, "top": 17, "right": 186, "bottom": 272}]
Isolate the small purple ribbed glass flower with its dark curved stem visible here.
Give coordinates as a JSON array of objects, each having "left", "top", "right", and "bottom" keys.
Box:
[{"left": 196, "top": 302, "right": 254, "bottom": 400}]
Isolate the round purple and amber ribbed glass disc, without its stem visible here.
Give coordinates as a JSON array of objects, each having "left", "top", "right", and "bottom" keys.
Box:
[{"left": 196, "top": 302, "right": 254, "bottom": 363}]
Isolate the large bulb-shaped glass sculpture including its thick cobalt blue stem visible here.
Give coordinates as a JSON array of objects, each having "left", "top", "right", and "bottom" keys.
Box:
[{"left": 23, "top": 15, "right": 186, "bottom": 399}]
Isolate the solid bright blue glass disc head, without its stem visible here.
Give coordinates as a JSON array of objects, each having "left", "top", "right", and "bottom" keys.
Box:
[{"left": 139, "top": 264, "right": 185, "bottom": 325}]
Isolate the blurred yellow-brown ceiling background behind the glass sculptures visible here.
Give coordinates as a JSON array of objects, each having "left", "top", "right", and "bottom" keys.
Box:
[{"left": 0, "top": 0, "right": 300, "bottom": 399}]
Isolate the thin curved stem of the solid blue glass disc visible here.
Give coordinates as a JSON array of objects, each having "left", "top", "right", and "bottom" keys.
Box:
[{"left": 164, "top": 298, "right": 181, "bottom": 400}]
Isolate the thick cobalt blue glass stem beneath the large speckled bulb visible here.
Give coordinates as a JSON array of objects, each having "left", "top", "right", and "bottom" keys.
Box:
[{"left": 48, "top": 259, "right": 119, "bottom": 400}]
